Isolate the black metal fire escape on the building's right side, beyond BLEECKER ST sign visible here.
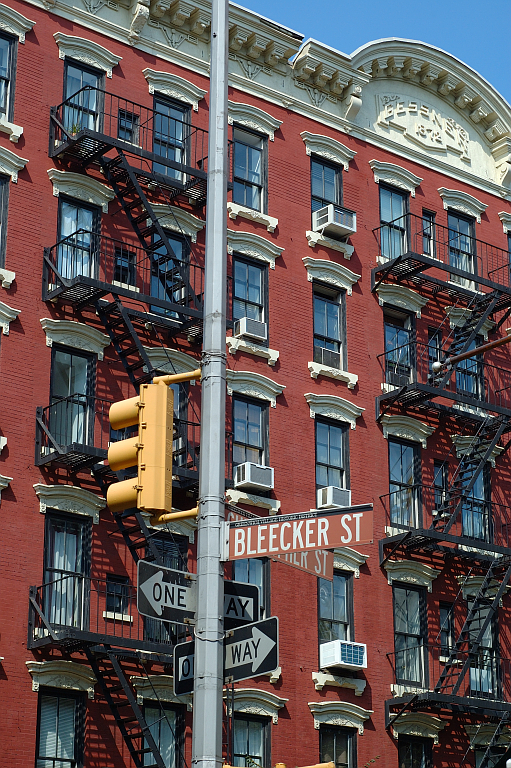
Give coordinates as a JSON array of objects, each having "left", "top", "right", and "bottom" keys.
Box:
[{"left": 372, "top": 214, "right": 511, "bottom": 768}]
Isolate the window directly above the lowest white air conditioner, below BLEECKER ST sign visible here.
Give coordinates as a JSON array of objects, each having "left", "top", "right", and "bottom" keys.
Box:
[{"left": 318, "top": 571, "right": 353, "bottom": 644}]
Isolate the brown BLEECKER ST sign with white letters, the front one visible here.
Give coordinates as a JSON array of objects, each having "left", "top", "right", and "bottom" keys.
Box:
[{"left": 226, "top": 504, "right": 373, "bottom": 560}]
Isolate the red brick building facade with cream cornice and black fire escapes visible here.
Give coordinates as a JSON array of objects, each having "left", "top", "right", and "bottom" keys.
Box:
[{"left": 0, "top": 0, "right": 511, "bottom": 768}]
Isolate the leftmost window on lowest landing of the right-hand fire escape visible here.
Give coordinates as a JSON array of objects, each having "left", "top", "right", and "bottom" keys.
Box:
[{"left": 392, "top": 586, "right": 427, "bottom": 688}]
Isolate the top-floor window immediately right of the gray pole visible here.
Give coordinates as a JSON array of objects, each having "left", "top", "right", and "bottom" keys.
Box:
[{"left": 232, "top": 128, "right": 266, "bottom": 212}]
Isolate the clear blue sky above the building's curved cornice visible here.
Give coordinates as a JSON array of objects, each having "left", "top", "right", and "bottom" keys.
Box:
[{"left": 236, "top": 0, "right": 511, "bottom": 103}]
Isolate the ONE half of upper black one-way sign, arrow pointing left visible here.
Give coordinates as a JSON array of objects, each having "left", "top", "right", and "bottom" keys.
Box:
[{"left": 137, "top": 560, "right": 197, "bottom": 624}]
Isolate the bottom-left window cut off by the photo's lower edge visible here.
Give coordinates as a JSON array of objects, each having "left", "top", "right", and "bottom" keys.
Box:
[{"left": 36, "top": 691, "right": 85, "bottom": 768}]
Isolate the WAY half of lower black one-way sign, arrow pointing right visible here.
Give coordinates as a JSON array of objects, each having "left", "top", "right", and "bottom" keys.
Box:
[{"left": 224, "top": 616, "right": 279, "bottom": 683}]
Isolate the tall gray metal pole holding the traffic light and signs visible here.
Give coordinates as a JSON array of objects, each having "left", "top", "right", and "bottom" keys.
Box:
[{"left": 192, "top": 0, "right": 229, "bottom": 768}]
